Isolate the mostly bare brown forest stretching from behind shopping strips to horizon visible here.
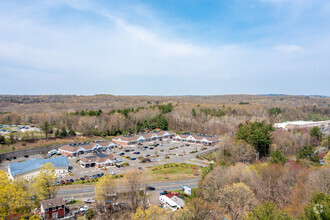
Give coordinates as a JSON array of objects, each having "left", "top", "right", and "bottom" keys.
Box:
[{"left": 0, "top": 95, "right": 330, "bottom": 136}]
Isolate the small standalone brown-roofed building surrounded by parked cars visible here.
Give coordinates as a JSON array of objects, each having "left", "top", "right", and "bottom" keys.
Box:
[{"left": 79, "top": 153, "right": 116, "bottom": 168}]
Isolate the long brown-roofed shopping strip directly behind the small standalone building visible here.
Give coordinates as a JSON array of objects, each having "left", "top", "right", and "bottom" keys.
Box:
[{"left": 58, "top": 141, "right": 117, "bottom": 157}]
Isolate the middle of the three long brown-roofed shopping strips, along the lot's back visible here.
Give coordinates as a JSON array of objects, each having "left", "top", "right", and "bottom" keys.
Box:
[{"left": 112, "top": 131, "right": 175, "bottom": 146}]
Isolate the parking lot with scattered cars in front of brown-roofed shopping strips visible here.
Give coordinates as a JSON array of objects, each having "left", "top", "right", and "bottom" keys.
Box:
[{"left": 0, "top": 139, "right": 215, "bottom": 181}]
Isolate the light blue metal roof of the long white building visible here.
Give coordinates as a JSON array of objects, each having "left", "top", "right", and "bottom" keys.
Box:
[{"left": 8, "top": 157, "right": 69, "bottom": 176}]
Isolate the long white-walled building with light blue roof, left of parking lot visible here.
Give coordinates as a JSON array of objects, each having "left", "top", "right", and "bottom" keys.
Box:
[{"left": 8, "top": 157, "right": 69, "bottom": 180}]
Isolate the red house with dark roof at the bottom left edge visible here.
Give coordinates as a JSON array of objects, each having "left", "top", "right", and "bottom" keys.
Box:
[{"left": 40, "top": 198, "right": 65, "bottom": 219}]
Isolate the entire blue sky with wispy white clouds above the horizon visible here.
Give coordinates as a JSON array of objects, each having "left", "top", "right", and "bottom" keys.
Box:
[{"left": 0, "top": 0, "right": 330, "bottom": 95}]
